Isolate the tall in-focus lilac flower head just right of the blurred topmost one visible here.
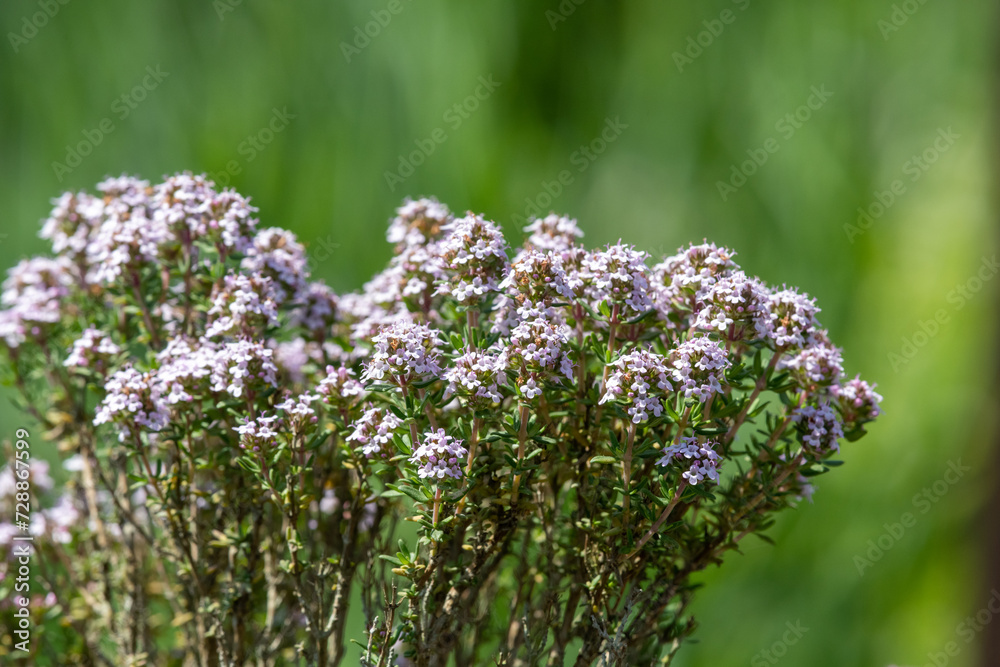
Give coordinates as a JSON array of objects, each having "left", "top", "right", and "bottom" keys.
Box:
[{"left": 436, "top": 213, "right": 507, "bottom": 304}]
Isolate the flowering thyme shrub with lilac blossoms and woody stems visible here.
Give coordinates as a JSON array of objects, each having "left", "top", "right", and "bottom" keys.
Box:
[{"left": 0, "top": 174, "right": 881, "bottom": 667}]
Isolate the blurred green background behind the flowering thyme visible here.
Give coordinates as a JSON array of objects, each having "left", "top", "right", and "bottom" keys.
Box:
[{"left": 0, "top": 0, "right": 1000, "bottom": 667}]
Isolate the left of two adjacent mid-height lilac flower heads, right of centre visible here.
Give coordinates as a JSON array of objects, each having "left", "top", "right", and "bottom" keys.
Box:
[{"left": 601, "top": 350, "right": 673, "bottom": 424}]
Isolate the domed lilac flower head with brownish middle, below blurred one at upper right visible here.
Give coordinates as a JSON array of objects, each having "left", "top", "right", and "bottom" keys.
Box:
[{"left": 694, "top": 271, "right": 771, "bottom": 342}]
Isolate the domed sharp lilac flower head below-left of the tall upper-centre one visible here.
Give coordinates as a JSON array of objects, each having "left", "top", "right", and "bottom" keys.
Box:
[{"left": 361, "top": 322, "right": 441, "bottom": 387}]
